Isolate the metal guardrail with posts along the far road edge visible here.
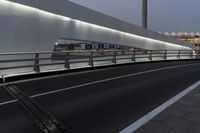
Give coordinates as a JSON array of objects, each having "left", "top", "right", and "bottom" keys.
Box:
[{"left": 0, "top": 50, "right": 200, "bottom": 78}]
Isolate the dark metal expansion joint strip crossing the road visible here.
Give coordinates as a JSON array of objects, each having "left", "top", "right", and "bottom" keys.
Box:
[{"left": 4, "top": 85, "right": 72, "bottom": 133}]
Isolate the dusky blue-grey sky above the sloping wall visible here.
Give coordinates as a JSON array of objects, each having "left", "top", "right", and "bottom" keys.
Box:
[{"left": 71, "top": 0, "right": 200, "bottom": 32}]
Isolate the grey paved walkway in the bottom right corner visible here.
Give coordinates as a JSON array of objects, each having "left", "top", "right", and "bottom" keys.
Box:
[{"left": 135, "top": 86, "right": 200, "bottom": 133}]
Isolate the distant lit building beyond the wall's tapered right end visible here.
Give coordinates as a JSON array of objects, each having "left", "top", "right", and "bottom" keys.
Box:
[{"left": 164, "top": 32, "right": 200, "bottom": 50}]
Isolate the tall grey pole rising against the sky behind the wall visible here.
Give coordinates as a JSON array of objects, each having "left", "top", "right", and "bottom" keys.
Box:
[{"left": 142, "top": 0, "right": 148, "bottom": 29}]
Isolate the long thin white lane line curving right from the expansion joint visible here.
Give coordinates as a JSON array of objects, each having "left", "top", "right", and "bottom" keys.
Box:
[{"left": 31, "top": 63, "right": 200, "bottom": 98}]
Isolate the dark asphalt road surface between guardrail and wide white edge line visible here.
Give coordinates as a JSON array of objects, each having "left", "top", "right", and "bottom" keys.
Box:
[{"left": 0, "top": 61, "right": 200, "bottom": 133}]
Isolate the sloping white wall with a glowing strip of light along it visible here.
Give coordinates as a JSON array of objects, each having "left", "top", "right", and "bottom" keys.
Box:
[{"left": 0, "top": 0, "right": 194, "bottom": 52}]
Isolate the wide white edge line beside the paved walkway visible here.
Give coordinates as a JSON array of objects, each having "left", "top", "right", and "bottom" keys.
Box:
[{"left": 119, "top": 80, "right": 200, "bottom": 133}]
